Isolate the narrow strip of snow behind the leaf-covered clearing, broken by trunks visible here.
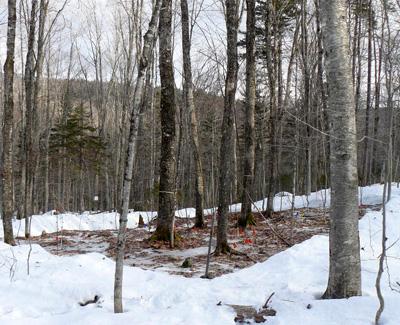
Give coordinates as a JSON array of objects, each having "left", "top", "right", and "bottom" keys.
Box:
[{"left": 0, "top": 185, "right": 386, "bottom": 238}]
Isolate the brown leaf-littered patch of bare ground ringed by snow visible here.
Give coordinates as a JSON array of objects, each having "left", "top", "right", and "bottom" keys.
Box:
[{"left": 18, "top": 205, "right": 380, "bottom": 277}]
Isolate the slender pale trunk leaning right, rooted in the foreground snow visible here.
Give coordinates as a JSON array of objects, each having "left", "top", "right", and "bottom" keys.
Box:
[{"left": 114, "top": 0, "right": 161, "bottom": 313}]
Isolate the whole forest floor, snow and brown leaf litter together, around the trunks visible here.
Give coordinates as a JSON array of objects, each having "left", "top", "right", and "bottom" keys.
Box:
[{"left": 0, "top": 184, "right": 400, "bottom": 325}]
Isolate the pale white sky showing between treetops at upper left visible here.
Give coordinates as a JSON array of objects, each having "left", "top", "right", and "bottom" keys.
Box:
[{"left": 0, "top": 0, "right": 231, "bottom": 91}]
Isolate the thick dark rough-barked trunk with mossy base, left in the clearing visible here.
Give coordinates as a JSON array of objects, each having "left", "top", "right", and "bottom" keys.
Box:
[{"left": 153, "top": 0, "right": 176, "bottom": 246}]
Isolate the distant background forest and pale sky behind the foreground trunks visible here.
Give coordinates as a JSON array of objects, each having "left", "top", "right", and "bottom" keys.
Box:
[{"left": 3, "top": 0, "right": 400, "bottom": 217}]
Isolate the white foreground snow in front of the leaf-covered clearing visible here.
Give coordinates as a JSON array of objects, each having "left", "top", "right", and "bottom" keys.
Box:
[{"left": 0, "top": 185, "right": 400, "bottom": 325}]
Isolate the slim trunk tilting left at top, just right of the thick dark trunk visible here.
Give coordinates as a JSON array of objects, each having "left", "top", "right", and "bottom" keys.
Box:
[{"left": 181, "top": 0, "right": 204, "bottom": 228}]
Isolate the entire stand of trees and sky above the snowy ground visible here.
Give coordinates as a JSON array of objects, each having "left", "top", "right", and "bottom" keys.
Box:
[{"left": 0, "top": 0, "right": 400, "bottom": 324}]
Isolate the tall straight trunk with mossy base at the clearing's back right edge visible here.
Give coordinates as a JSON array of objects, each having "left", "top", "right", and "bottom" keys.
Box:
[{"left": 239, "top": 0, "right": 256, "bottom": 227}]
